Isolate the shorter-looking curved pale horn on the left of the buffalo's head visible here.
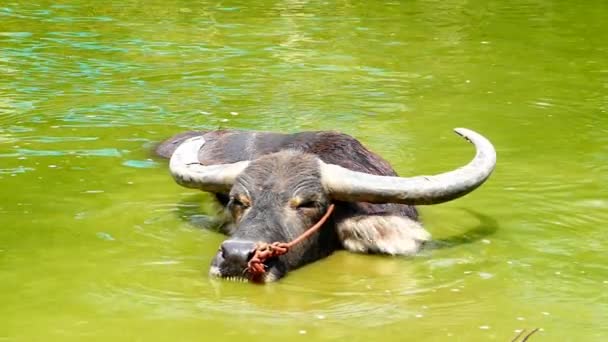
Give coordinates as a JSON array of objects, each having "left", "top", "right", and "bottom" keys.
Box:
[{"left": 169, "top": 136, "right": 249, "bottom": 192}]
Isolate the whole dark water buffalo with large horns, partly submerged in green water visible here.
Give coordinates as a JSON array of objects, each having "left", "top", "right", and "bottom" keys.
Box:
[{"left": 156, "top": 128, "right": 496, "bottom": 282}]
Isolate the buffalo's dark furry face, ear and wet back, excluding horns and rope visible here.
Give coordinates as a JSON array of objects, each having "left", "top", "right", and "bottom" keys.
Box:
[{"left": 156, "top": 131, "right": 424, "bottom": 279}]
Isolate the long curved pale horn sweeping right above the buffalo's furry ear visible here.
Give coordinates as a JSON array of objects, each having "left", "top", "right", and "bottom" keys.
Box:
[{"left": 320, "top": 128, "right": 496, "bottom": 205}]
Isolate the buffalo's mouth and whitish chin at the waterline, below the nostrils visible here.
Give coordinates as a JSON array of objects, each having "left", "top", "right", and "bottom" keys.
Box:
[{"left": 209, "top": 253, "right": 286, "bottom": 284}]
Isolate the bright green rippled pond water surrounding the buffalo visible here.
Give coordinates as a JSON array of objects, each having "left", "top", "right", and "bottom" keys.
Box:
[{"left": 0, "top": 0, "right": 608, "bottom": 341}]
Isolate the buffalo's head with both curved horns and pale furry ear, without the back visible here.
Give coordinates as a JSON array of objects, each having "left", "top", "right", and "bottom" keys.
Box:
[{"left": 165, "top": 128, "right": 496, "bottom": 281}]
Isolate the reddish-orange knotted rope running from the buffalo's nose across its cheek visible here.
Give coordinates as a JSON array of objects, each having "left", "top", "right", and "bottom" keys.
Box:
[{"left": 245, "top": 204, "right": 334, "bottom": 279}]
